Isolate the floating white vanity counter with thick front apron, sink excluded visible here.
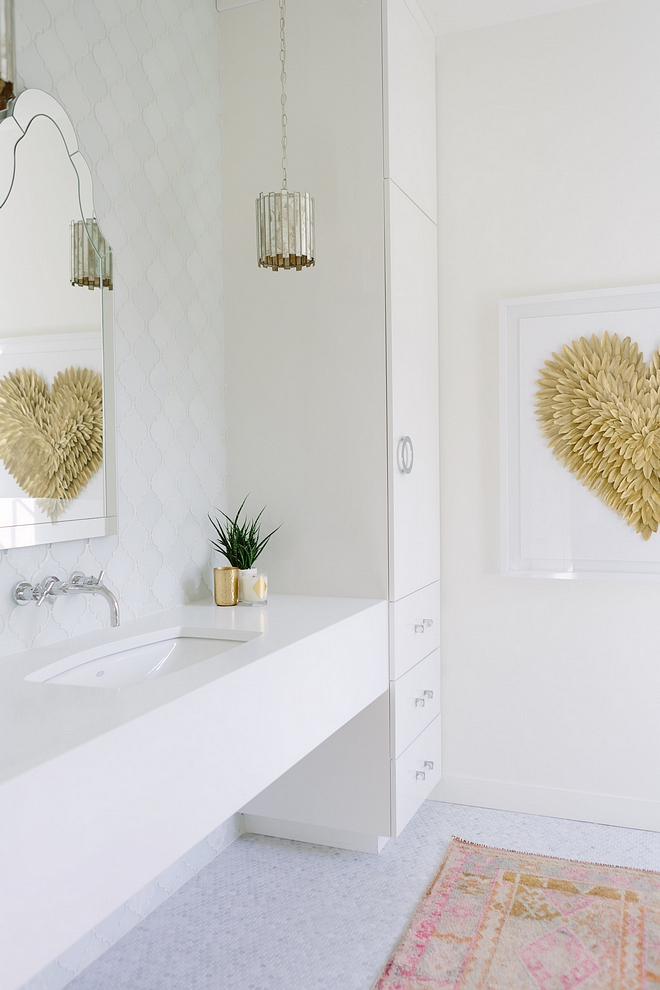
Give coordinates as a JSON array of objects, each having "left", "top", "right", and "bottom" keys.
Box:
[{"left": 0, "top": 595, "right": 389, "bottom": 990}]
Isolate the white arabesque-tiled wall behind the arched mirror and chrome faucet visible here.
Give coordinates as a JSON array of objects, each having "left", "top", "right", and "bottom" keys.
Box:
[{"left": 0, "top": 0, "right": 226, "bottom": 655}]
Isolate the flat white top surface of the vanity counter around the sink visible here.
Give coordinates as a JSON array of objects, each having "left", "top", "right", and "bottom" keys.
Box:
[{"left": 0, "top": 595, "right": 382, "bottom": 784}]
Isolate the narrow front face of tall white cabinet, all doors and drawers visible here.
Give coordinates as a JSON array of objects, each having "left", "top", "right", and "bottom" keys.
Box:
[{"left": 383, "top": 0, "right": 440, "bottom": 835}]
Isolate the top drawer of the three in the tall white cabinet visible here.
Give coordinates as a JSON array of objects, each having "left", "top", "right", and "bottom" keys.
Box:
[{"left": 390, "top": 581, "right": 440, "bottom": 680}]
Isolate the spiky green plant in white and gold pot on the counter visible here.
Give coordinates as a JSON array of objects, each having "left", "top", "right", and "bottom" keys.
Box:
[{"left": 209, "top": 495, "right": 280, "bottom": 605}]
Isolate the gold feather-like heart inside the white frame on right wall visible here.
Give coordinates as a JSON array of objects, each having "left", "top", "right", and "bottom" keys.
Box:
[{"left": 536, "top": 333, "right": 660, "bottom": 540}]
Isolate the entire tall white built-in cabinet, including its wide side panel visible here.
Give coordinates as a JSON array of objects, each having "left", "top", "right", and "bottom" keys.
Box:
[{"left": 220, "top": 0, "right": 440, "bottom": 849}]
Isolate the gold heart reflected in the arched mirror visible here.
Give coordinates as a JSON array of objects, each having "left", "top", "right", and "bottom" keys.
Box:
[{"left": 0, "top": 368, "right": 103, "bottom": 522}]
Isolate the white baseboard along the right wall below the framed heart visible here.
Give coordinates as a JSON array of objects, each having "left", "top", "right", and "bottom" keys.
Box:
[{"left": 429, "top": 777, "right": 660, "bottom": 832}]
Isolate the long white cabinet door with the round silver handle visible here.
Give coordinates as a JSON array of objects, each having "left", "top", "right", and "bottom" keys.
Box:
[{"left": 386, "top": 182, "right": 440, "bottom": 601}]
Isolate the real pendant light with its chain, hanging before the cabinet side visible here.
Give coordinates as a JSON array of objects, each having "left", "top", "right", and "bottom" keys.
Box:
[{"left": 256, "top": 0, "right": 315, "bottom": 272}]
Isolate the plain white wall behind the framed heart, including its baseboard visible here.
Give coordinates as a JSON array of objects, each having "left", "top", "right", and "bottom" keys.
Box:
[{"left": 434, "top": 0, "right": 660, "bottom": 829}]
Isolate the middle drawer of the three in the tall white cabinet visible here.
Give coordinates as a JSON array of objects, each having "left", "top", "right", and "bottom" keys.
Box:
[{"left": 390, "top": 650, "right": 440, "bottom": 758}]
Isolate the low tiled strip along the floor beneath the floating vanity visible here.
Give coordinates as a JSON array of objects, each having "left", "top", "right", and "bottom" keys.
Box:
[{"left": 21, "top": 812, "right": 243, "bottom": 990}]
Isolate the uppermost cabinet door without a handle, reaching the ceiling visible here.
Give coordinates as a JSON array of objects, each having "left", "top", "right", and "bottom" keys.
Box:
[{"left": 383, "top": 0, "right": 437, "bottom": 220}]
